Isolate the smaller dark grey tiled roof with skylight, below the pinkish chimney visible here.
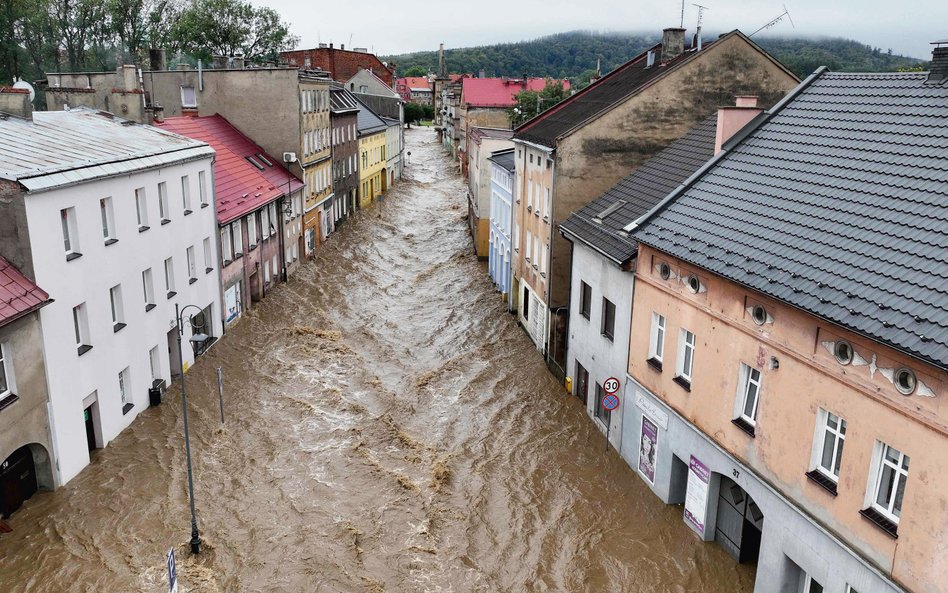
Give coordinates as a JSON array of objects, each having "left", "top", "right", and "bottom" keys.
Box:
[{"left": 560, "top": 114, "right": 717, "bottom": 264}]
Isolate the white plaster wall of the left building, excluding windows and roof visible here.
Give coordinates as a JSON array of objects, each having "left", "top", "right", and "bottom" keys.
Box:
[{"left": 25, "top": 157, "right": 221, "bottom": 484}]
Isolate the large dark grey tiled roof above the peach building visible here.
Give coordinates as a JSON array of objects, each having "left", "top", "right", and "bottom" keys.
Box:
[{"left": 633, "top": 71, "right": 948, "bottom": 369}]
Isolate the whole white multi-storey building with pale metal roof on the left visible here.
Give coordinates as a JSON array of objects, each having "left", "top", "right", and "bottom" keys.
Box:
[{"left": 0, "top": 110, "right": 221, "bottom": 483}]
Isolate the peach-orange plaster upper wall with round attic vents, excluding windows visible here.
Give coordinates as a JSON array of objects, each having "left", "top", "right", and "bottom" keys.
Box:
[{"left": 628, "top": 246, "right": 948, "bottom": 592}]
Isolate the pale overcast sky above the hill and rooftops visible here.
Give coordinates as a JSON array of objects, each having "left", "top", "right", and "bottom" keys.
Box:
[{"left": 260, "top": 0, "right": 948, "bottom": 59}]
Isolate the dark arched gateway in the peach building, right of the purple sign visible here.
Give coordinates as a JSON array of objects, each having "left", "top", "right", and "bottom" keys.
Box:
[{"left": 714, "top": 476, "right": 764, "bottom": 564}]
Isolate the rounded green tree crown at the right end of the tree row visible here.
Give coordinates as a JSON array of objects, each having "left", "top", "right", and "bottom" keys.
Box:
[{"left": 170, "top": 0, "right": 299, "bottom": 61}]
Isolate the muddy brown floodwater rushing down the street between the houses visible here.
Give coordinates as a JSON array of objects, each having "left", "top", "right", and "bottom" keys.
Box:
[{"left": 0, "top": 129, "right": 754, "bottom": 593}]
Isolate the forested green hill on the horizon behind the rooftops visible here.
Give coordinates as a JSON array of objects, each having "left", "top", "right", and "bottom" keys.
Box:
[{"left": 382, "top": 31, "right": 924, "bottom": 80}]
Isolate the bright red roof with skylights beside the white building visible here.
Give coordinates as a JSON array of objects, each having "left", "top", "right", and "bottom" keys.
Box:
[{"left": 155, "top": 115, "right": 303, "bottom": 224}]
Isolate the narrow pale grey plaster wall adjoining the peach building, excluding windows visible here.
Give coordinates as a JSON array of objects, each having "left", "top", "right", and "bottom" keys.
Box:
[{"left": 566, "top": 241, "right": 635, "bottom": 449}]
